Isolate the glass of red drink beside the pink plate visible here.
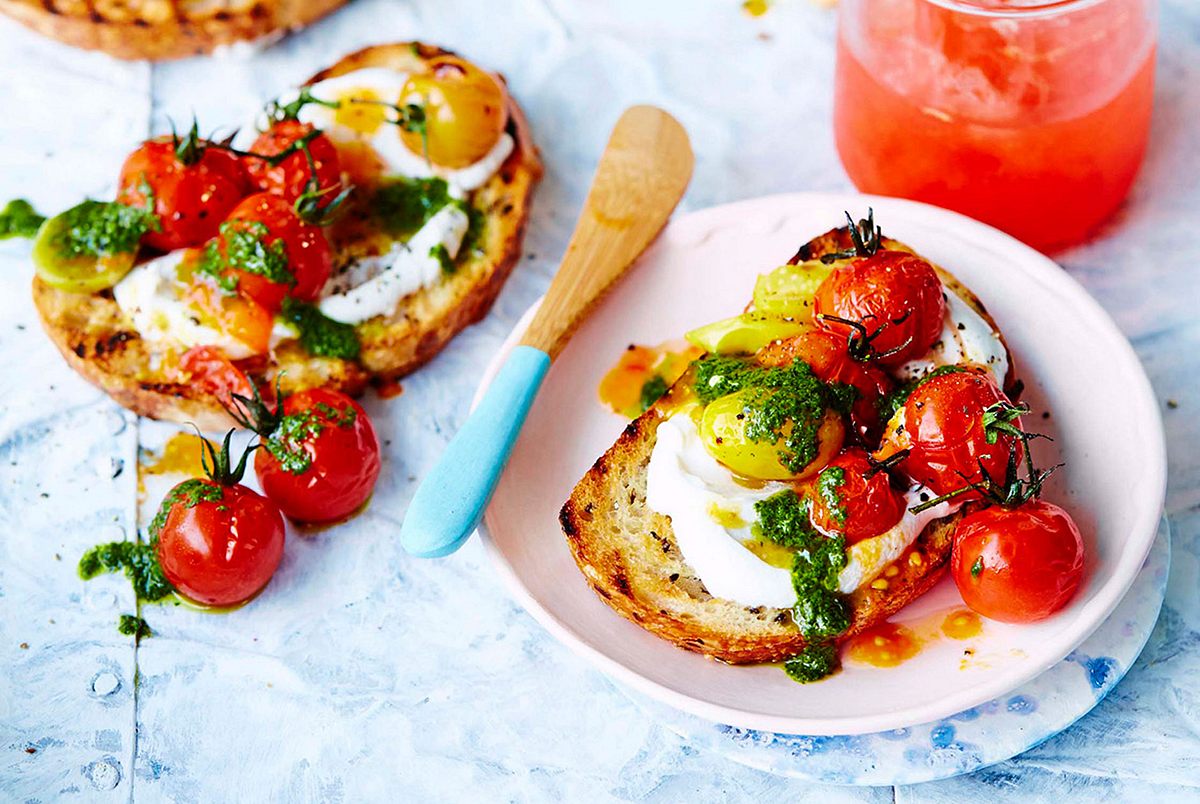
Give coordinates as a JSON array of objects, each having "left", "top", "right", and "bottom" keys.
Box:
[{"left": 834, "top": 0, "right": 1154, "bottom": 248}]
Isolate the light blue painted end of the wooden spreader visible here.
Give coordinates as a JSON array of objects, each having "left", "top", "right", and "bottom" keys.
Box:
[{"left": 400, "top": 346, "right": 550, "bottom": 558}]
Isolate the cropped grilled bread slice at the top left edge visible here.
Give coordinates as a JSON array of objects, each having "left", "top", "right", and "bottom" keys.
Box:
[{"left": 0, "top": 0, "right": 346, "bottom": 60}]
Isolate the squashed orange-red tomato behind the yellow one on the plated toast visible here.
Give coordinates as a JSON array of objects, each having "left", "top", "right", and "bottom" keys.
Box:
[{"left": 757, "top": 330, "right": 895, "bottom": 439}]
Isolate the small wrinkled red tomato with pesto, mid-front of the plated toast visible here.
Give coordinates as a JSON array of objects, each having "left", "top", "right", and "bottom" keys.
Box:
[{"left": 810, "top": 449, "right": 905, "bottom": 544}]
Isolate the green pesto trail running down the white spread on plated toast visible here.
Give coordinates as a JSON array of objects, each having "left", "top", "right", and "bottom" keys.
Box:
[{"left": 754, "top": 491, "right": 850, "bottom": 642}]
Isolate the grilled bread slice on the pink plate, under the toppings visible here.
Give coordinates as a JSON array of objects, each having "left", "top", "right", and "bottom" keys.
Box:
[{"left": 559, "top": 229, "right": 1012, "bottom": 664}]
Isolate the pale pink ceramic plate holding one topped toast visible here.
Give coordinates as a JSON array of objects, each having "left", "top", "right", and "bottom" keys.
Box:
[{"left": 480, "top": 193, "right": 1166, "bottom": 734}]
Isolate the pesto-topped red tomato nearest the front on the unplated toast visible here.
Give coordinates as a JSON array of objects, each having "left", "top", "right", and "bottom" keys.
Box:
[{"left": 209, "top": 193, "right": 334, "bottom": 312}]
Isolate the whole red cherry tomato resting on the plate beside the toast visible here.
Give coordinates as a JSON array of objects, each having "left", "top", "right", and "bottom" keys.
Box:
[{"left": 950, "top": 499, "right": 1084, "bottom": 623}]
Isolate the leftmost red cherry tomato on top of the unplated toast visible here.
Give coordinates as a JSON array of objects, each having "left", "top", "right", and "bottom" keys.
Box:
[{"left": 116, "top": 137, "right": 251, "bottom": 251}]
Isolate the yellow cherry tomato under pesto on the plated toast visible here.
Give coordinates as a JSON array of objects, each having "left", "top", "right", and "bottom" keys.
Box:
[{"left": 700, "top": 389, "right": 846, "bottom": 480}]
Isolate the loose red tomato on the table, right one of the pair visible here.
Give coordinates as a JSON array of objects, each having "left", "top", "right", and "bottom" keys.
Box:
[{"left": 254, "top": 389, "right": 380, "bottom": 522}]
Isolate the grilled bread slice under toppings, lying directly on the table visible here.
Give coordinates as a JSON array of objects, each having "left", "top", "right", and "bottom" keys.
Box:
[{"left": 34, "top": 43, "right": 541, "bottom": 430}]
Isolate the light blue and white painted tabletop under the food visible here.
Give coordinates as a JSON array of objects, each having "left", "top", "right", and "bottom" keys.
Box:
[{"left": 0, "top": 0, "right": 1200, "bottom": 802}]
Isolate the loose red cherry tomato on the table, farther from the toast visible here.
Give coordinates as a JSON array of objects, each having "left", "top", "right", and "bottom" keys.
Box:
[{"left": 151, "top": 479, "right": 283, "bottom": 606}]
